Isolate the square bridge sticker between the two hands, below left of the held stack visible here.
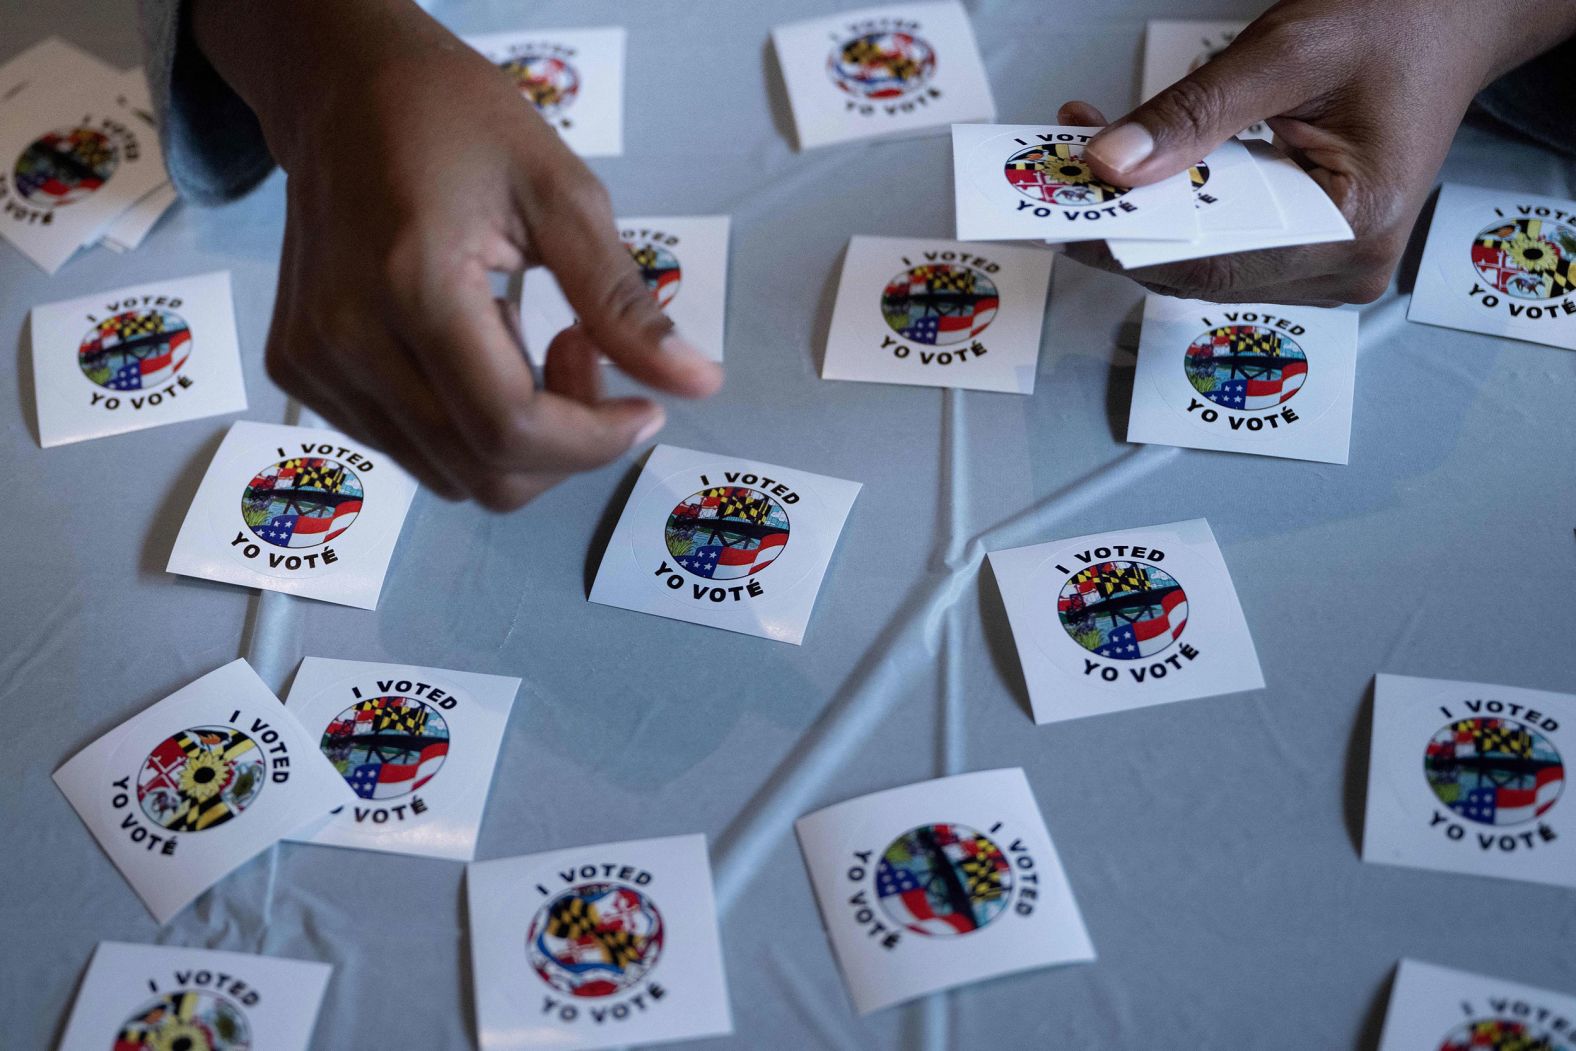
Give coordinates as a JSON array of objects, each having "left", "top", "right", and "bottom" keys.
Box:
[{"left": 821, "top": 236, "right": 1054, "bottom": 394}]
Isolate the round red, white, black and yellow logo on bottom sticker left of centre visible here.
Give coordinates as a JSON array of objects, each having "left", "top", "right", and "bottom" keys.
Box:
[{"left": 526, "top": 882, "right": 663, "bottom": 997}]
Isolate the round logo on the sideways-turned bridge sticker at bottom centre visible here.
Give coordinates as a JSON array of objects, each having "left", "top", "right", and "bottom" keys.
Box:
[{"left": 876, "top": 824, "right": 1012, "bottom": 934}]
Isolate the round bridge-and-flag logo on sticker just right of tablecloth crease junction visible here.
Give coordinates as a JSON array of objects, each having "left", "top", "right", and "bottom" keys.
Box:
[{"left": 1056, "top": 561, "right": 1187, "bottom": 660}]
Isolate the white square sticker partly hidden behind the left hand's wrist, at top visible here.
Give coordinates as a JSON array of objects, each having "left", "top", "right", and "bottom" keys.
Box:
[{"left": 465, "top": 25, "right": 624, "bottom": 158}]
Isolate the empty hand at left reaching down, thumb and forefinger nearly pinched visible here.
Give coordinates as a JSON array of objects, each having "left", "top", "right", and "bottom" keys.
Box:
[{"left": 192, "top": 0, "right": 722, "bottom": 509}]
